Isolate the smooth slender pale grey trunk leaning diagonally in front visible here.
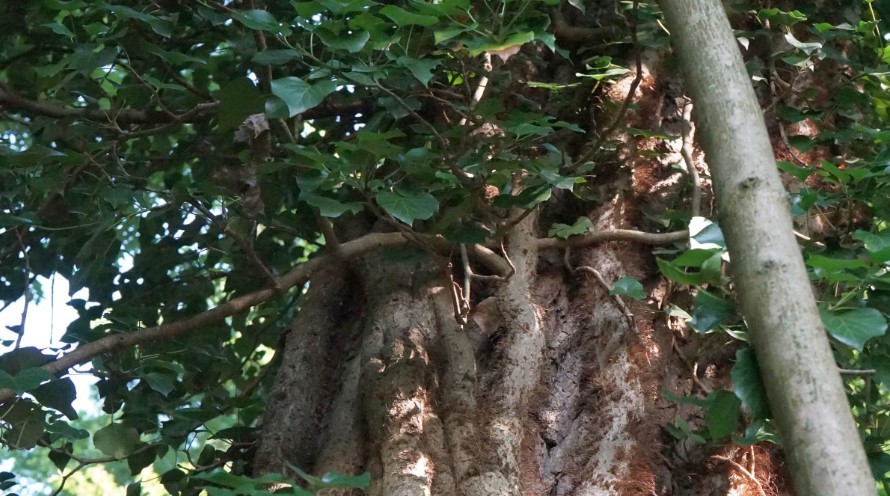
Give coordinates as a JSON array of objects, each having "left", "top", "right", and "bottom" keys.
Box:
[{"left": 660, "top": 0, "right": 875, "bottom": 495}]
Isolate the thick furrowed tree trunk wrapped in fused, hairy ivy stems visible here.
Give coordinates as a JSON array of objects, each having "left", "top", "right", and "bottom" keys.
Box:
[{"left": 254, "top": 58, "right": 787, "bottom": 496}]
